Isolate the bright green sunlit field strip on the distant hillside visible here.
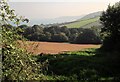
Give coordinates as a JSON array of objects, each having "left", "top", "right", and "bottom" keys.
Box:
[{"left": 65, "top": 17, "right": 99, "bottom": 28}]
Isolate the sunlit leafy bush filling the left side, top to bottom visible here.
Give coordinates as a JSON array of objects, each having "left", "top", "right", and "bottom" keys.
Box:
[{"left": 0, "top": 0, "right": 43, "bottom": 81}]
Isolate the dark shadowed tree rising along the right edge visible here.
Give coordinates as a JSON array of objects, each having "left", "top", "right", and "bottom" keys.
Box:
[{"left": 100, "top": 2, "right": 120, "bottom": 51}]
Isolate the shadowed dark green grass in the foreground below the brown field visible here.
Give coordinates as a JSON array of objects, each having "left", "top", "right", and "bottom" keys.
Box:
[{"left": 32, "top": 49, "right": 120, "bottom": 81}]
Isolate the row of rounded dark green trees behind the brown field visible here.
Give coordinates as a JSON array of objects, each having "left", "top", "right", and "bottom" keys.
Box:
[{"left": 19, "top": 25, "right": 101, "bottom": 44}]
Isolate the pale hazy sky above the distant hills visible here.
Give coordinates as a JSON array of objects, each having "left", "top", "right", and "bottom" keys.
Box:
[{"left": 9, "top": 0, "right": 119, "bottom": 19}]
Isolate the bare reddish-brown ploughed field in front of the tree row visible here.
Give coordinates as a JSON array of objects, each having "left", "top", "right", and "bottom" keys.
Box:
[{"left": 18, "top": 41, "right": 100, "bottom": 54}]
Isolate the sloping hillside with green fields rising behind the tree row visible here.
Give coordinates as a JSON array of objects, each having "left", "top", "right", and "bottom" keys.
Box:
[{"left": 64, "top": 11, "right": 101, "bottom": 28}]
